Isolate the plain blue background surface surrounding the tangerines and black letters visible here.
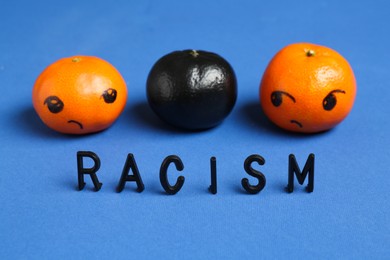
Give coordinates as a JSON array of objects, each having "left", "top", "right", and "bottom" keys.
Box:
[{"left": 0, "top": 0, "right": 390, "bottom": 259}]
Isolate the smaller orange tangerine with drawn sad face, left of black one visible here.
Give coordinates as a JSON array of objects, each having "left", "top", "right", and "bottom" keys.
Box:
[{"left": 33, "top": 56, "right": 127, "bottom": 134}]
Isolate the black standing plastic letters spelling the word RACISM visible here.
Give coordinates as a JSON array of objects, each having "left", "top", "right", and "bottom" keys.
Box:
[{"left": 77, "top": 151, "right": 314, "bottom": 195}]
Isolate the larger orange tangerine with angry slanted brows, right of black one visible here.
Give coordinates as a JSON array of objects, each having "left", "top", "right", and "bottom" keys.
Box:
[{"left": 260, "top": 44, "right": 356, "bottom": 133}]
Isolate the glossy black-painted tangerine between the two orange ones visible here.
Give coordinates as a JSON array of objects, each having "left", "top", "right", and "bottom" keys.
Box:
[{"left": 146, "top": 50, "right": 237, "bottom": 130}]
